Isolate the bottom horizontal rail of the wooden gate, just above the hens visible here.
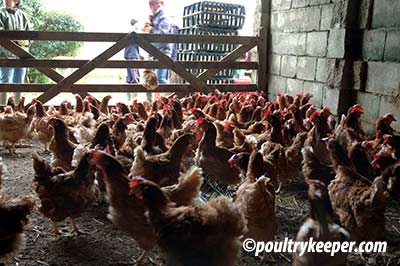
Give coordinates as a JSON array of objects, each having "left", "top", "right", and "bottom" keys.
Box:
[{"left": 0, "top": 83, "right": 257, "bottom": 93}]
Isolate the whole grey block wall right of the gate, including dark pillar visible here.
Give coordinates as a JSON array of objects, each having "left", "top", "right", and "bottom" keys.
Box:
[{"left": 268, "top": 0, "right": 400, "bottom": 132}]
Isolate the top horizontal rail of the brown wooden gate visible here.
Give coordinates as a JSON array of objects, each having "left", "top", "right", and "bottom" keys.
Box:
[{"left": 0, "top": 31, "right": 257, "bottom": 44}]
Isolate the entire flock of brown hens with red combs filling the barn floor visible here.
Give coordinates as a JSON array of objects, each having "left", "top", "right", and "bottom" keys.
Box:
[{"left": 0, "top": 91, "right": 400, "bottom": 265}]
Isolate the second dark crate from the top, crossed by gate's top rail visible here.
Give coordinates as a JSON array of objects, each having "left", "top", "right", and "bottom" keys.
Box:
[{"left": 178, "top": 27, "right": 238, "bottom": 53}]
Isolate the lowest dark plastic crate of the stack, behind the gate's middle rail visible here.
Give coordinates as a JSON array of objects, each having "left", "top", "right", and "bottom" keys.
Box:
[{"left": 178, "top": 51, "right": 234, "bottom": 79}]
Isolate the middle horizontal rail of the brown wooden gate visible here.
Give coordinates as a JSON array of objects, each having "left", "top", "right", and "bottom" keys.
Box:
[{"left": 0, "top": 59, "right": 258, "bottom": 69}]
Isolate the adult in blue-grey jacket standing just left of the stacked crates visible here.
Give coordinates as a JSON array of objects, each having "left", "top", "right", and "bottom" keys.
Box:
[{"left": 149, "top": 0, "right": 173, "bottom": 84}]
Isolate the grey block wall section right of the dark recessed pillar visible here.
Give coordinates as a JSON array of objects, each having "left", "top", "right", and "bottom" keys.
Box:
[{"left": 355, "top": 0, "right": 400, "bottom": 131}]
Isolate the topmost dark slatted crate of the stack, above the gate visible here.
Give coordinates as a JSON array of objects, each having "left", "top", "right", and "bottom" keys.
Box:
[{"left": 183, "top": 1, "right": 246, "bottom": 30}]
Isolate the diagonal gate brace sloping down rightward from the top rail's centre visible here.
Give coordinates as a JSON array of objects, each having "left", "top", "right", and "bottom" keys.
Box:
[{"left": 132, "top": 32, "right": 207, "bottom": 90}]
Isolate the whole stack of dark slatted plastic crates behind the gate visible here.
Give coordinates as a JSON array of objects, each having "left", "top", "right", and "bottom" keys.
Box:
[{"left": 178, "top": 1, "right": 246, "bottom": 84}]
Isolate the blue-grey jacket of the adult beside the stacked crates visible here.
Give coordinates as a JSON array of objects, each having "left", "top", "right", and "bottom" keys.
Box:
[{"left": 150, "top": 8, "right": 172, "bottom": 57}]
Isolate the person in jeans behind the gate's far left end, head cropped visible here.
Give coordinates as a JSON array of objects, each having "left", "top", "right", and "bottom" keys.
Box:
[{"left": 0, "top": 0, "right": 31, "bottom": 104}]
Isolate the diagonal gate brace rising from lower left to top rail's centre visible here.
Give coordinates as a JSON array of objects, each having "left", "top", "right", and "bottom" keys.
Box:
[{"left": 38, "top": 33, "right": 133, "bottom": 103}]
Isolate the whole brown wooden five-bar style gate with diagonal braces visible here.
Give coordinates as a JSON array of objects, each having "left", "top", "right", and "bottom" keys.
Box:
[{"left": 0, "top": 31, "right": 266, "bottom": 102}]
